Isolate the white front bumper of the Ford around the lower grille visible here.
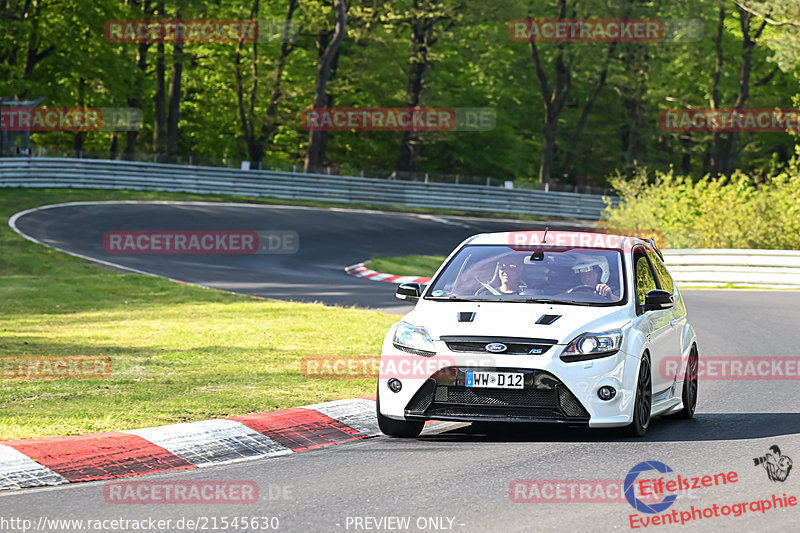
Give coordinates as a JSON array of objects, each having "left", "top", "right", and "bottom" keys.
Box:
[{"left": 378, "top": 336, "right": 639, "bottom": 427}]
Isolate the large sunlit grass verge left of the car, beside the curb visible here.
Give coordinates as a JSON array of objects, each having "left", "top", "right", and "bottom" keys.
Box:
[{"left": 0, "top": 189, "right": 396, "bottom": 440}]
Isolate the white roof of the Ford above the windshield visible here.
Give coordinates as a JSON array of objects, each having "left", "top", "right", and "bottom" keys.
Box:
[{"left": 465, "top": 230, "right": 654, "bottom": 251}]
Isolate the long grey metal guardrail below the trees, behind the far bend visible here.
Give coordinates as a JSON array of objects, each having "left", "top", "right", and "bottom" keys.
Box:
[{"left": 0, "top": 157, "right": 616, "bottom": 220}]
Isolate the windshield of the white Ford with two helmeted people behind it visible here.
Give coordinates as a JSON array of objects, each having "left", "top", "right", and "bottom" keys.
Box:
[{"left": 426, "top": 245, "right": 624, "bottom": 305}]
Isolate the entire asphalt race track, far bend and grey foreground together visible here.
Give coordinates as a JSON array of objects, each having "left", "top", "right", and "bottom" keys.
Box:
[{"left": 0, "top": 201, "right": 800, "bottom": 532}]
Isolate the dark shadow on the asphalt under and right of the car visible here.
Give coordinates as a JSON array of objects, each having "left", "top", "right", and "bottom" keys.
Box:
[{"left": 418, "top": 413, "right": 800, "bottom": 442}]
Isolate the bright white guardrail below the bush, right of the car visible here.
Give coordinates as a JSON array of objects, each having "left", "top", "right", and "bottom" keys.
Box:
[{"left": 663, "top": 249, "right": 800, "bottom": 288}]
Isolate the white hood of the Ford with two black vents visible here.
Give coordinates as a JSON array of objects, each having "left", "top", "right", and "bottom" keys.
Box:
[{"left": 403, "top": 300, "right": 632, "bottom": 344}]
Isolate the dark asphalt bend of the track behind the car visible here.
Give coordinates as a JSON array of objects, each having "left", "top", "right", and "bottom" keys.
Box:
[{"left": 6, "top": 202, "right": 589, "bottom": 313}]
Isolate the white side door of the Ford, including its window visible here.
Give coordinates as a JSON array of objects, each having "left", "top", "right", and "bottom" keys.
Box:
[{"left": 633, "top": 248, "right": 674, "bottom": 394}]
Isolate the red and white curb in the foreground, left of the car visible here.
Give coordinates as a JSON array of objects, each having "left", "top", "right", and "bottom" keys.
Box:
[{"left": 0, "top": 398, "right": 380, "bottom": 490}]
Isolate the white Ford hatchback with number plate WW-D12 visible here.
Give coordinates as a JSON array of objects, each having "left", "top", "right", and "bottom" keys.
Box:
[{"left": 377, "top": 231, "right": 698, "bottom": 437}]
